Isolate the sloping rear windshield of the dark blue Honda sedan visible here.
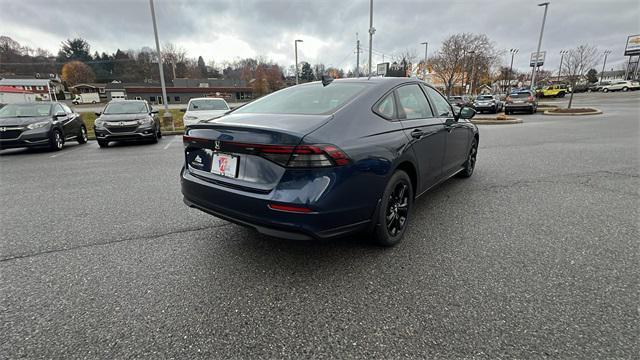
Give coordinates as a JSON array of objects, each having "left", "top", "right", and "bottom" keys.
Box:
[{"left": 235, "top": 82, "right": 367, "bottom": 115}]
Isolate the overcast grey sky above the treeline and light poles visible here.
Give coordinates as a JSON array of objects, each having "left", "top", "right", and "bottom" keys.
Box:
[{"left": 0, "top": 0, "right": 640, "bottom": 74}]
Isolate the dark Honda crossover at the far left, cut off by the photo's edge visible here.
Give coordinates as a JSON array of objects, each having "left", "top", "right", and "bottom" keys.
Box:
[{"left": 0, "top": 102, "right": 87, "bottom": 150}]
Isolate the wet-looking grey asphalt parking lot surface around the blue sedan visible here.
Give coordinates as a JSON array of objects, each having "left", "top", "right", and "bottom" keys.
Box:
[{"left": 0, "top": 92, "right": 640, "bottom": 359}]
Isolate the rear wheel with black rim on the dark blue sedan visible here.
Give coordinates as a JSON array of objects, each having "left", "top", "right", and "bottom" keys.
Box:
[{"left": 373, "top": 170, "right": 413, "bottom": 246}]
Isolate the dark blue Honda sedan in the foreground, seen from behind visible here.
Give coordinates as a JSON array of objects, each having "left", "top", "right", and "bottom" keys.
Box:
[{"left": 181, "top": 78, "right": 479, "bottom": 246}]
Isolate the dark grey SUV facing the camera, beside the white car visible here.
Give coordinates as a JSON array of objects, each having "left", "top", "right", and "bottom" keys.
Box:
[{"left": 93, "top": 100, "right": 162, "bottom": 147}]
